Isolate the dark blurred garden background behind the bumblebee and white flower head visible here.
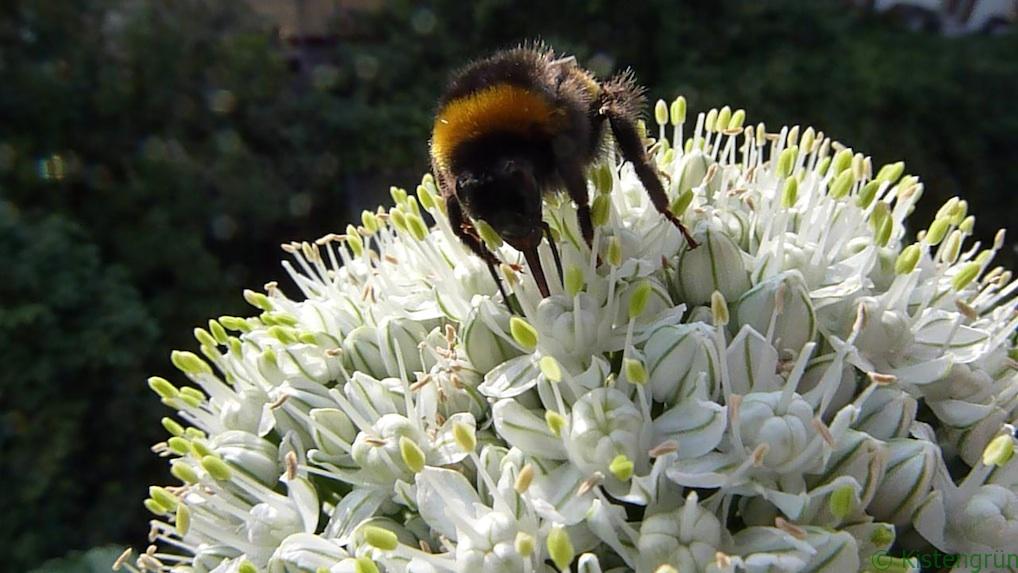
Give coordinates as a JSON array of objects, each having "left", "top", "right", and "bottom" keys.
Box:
[{"left": 0, "top": 0, "right": 1018, "bottom": 571}]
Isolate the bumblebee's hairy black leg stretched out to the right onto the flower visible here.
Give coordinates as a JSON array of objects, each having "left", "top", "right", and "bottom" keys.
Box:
[{"left": 599, "top": 72, "right": 696, "bottom": 248}]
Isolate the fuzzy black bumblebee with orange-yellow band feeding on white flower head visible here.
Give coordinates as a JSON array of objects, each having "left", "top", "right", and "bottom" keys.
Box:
[{"left": 431, "top": 46, "right": 696, "bottom": 302}]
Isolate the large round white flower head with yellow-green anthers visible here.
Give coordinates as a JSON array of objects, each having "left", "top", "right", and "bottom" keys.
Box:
[{"left": 131, "top": 98, "right": 1018, "bottom": 573}]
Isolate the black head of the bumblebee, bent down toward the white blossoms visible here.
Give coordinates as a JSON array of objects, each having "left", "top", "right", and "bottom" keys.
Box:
[{"left": 456, "top": 158, "right": 544, "bottom": 250}]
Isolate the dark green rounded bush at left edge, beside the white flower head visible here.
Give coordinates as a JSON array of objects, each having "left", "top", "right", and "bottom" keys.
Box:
[{"left": 0, "top": 202, "right": 157, "bottom": 570}]
